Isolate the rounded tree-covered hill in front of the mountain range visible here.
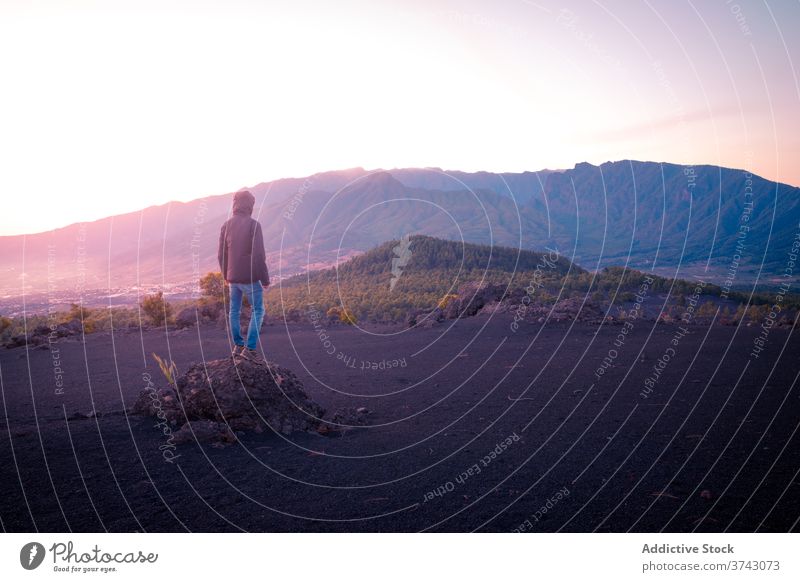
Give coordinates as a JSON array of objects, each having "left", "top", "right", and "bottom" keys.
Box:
[{"left": 267, "top": 235, "right": 576, "bottom": 320}]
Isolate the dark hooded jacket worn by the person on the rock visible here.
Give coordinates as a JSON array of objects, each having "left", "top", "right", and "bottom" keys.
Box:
[{"left": 217, "top": 190, "right": 269, "bottom": 287}]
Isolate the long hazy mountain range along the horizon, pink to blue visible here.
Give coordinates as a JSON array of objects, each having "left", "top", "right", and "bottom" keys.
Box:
[{"left": 0, "top": 160, "right": 800, "bottom": 306}]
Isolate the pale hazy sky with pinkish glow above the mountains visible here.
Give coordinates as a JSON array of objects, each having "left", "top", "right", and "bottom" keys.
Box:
[{"left": 0, "top": 0, "right": 800, "bottom": 235}]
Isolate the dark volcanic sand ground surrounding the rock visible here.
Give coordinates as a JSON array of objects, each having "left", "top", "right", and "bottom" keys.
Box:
[{"left": 0, "top": 315, "right": 800, "bottom": 532}]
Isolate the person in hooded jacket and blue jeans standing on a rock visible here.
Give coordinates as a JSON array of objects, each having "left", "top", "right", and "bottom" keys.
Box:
[{"left": 217, "top": 190, "right": 269, "bottom": 361}]
